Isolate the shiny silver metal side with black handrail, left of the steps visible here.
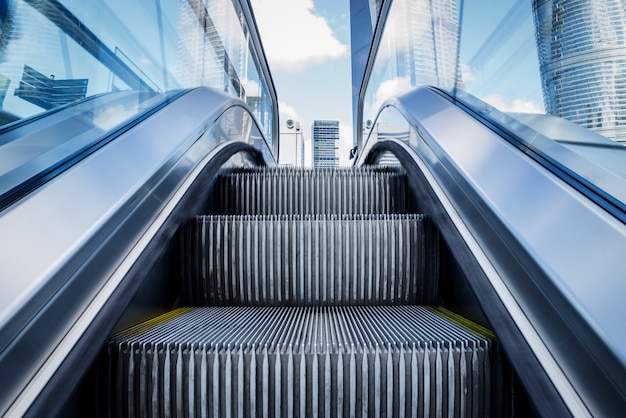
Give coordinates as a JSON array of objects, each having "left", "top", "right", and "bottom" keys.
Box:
[{"left": 0, "top": 88, "right": 273, "bottom": 416}]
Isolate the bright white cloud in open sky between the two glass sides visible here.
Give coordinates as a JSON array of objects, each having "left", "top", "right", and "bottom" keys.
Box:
[{"left": 252, "top": 0, "right": 348, "bottom": 71}]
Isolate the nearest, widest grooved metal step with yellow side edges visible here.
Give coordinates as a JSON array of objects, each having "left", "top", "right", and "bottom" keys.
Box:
[{"left": 100, "top": 306, "right": 501, "bottom": 417}]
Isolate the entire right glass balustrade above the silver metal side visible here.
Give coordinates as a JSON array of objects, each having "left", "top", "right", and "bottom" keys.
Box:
[{"left": 361, "top": 0, "right": 626, "bottom": 209}]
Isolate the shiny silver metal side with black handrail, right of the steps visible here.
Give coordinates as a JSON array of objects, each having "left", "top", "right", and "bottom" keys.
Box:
[{"left": 359, "top": 88, "right": 626, "bottom": 414}]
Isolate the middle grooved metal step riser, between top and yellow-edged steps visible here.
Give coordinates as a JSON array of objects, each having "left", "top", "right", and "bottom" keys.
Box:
[{"left": 182, "top": 215, "right": 438, "bottom": 306}]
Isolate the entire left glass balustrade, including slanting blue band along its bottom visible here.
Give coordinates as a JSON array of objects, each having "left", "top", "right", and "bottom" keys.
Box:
[{"left": 0, "top": 0, "right": 278, "bottom": 206}]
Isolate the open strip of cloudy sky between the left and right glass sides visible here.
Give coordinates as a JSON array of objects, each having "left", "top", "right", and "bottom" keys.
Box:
[{"left": 251, "top": 0, "right": 352, "bottom": 164}]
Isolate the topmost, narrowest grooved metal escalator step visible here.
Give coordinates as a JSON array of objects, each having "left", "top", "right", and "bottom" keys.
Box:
[{"left": 217, "top": 167, "right": 406, "bottom": 215}]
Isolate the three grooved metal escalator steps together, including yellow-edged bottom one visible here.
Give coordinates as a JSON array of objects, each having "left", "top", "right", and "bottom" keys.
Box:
[{"left": 97, "top": 166, "right": 512, "bottom": 417}]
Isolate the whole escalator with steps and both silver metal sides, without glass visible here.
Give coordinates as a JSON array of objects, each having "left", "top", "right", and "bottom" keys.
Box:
[{"left": 0, "top": 89, "right": 626, "bottom": 417}]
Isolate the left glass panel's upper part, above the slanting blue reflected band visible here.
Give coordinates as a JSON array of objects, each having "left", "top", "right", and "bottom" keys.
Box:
[{"left": 0, "top": 0, "right": 274, "bottom": 145}]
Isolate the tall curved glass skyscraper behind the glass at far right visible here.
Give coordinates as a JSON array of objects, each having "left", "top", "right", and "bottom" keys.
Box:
[{"left": 533, "top": 0, "right": 626, "bottom": 142}]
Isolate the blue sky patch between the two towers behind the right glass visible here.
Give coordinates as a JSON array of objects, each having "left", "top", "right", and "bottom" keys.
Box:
[{"left": 459, "top": 0, "right": 544, "bottom": 113}]
